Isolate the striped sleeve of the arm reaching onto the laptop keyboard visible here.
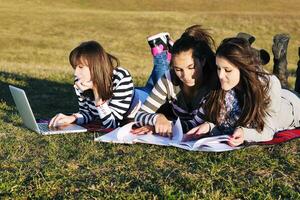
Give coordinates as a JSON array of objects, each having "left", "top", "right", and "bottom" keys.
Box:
[{"left": 75, "top": 88, "right": 94, "bottom": 124}]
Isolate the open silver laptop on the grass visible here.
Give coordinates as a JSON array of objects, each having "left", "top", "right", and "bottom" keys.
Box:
[{"left": 9, "top": 85, "right": 87, "bottom": 135}]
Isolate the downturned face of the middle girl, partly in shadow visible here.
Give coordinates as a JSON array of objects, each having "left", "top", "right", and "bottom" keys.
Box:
[{"left": 173, "top": 50, "right": 197, "bottom": 87}]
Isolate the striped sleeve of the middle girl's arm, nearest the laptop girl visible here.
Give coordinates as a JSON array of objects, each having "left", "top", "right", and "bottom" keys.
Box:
[{"left": 135, "top": 74, "right": 172, "bottom": 126}]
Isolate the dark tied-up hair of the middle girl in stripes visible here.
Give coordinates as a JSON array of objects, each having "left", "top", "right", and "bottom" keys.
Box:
[{"left": 170, "top": 25, "right": 217, "bottom": 87}]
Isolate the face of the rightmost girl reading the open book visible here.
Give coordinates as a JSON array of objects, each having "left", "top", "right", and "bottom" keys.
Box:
[{"left": 216, "top": 56, "right": 240, "bottom": 91}]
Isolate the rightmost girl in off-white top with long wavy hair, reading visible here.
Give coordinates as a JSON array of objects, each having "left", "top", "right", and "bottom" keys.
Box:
[{"left": 187, "top": 38, "right": 300, "bottom": 146}]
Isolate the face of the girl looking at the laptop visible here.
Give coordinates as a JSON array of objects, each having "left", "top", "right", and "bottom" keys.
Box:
[{"left": 74, "top": 59, "right": 91, "bottom": 82}]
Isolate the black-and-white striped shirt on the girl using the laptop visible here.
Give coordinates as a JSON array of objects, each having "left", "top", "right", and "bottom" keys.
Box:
[{"left": 75, "top": 67, "right": 134, "bottom": 128}]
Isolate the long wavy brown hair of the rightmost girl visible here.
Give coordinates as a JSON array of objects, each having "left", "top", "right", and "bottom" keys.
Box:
[{"left": 204, "top": 38, "right": 270, "bottom": 132}]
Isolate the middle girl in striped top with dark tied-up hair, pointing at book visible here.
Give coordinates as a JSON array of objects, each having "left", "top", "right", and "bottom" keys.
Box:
[{"left": 132, "top": 25, "right": 217, "bottom": 136}]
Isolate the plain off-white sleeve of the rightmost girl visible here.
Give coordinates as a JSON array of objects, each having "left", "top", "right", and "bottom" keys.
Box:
[{"left": 241, "top": 75, "right": 281, "bottom": 142}]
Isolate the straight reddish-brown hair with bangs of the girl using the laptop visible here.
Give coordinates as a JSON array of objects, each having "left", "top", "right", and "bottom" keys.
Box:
[{"left": 69, "top": 41, "right": 119, "bottom": 100}]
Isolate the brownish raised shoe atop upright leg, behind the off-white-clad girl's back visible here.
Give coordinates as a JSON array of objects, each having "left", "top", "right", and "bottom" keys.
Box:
[{"left": 272, "top": 33, "right": 290, "bottom": 59}]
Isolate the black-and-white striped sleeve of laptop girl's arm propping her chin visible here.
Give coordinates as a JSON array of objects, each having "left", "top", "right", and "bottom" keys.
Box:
[{"left": 96, "top": 68, "right": 134, "bottom": 128}]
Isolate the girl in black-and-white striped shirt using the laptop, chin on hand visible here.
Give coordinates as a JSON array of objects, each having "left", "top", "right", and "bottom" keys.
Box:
[{"left": 49, "top": 41, "right": 134, "bottom": 128}]
